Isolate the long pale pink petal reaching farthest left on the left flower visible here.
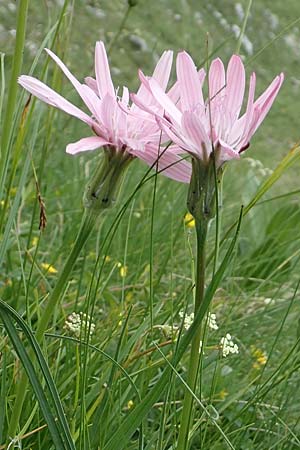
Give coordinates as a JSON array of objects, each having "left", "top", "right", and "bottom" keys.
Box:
[{"left": 18, "top": 75, "right": 94, "bottom": 126}]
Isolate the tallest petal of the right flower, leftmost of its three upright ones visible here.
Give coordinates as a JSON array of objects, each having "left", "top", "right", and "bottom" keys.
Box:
[{"left": 176, "top": 52, "right": 204, "bottom": 111}]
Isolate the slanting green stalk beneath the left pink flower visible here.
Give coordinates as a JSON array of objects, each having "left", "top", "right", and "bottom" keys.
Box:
[{"left": 8, "top": 210, "right": 97, "bottom": 437}]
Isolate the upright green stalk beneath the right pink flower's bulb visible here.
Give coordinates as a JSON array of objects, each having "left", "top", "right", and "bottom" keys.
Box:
[{"left": 177, "top": 219, "right": 208, "bottom": 450}]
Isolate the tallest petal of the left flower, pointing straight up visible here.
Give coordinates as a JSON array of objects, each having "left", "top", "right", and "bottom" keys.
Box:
[{"left": 95, "top": 41, "right": 116, "bottom": 98}]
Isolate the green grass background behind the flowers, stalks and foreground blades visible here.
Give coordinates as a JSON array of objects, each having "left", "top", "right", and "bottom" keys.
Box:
[{"left": 0, "top": 0, "right": 300, "bottom": 450}]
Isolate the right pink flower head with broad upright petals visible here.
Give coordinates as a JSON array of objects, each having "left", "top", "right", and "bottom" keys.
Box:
[{"left": 132, "top": 52, "right": 284, "bottom": 167}]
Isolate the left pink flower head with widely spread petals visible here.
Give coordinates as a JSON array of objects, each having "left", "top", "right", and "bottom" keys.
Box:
[{"left": 19, "top": 42, "right": 191, "bottom": 183}]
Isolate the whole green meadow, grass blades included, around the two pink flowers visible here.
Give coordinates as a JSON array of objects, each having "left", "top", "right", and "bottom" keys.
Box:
[{"left": 0, "top": 0, "right": 300, "bottom": 450}]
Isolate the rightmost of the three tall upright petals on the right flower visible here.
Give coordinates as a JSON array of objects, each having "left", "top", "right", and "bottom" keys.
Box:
[{"left": 225, "top": 55, "right": 245, "bottom": 123}]
